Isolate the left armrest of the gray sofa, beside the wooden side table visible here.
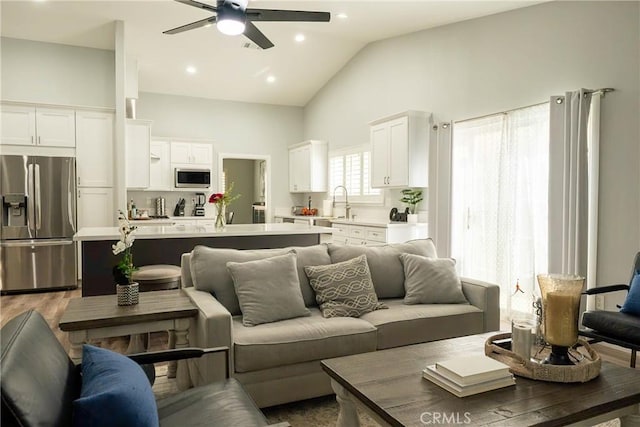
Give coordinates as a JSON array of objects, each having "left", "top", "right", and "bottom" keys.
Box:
[{"left": 184, "top": 287, "right": 234, "bottom": 386}]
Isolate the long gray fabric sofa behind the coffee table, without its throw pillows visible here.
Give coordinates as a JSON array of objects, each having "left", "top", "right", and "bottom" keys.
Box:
[{"left": 178, "top": 239, "right": 500, "bottom": 407}]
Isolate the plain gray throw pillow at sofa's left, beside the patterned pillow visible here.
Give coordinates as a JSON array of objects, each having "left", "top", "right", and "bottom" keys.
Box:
[{"left": 227, "top": 252, "right": 311, "bottom": 326}]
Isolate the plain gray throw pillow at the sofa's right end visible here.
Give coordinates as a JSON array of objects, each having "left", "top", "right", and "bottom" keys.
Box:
[{"left": 400, "top": 254, "right": 467, "bottom": 304}]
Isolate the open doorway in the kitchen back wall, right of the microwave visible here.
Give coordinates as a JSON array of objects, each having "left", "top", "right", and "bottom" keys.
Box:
[{"left": 218, "top": 153, "right": 271, "bottom": 224}]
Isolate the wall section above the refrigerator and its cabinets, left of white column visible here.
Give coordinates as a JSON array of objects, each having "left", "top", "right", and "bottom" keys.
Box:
[{"left": 0, "top": 37, "right": 115, "bottom": 108}]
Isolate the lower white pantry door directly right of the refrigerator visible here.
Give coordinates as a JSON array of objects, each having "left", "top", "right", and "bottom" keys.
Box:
[{"left": 78, "top": 187, "right": 117, "bottom": 228}]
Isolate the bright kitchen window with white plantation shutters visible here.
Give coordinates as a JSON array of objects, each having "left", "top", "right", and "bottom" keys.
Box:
[{"left": 329, "top": 146, "right": 384, "bottom": 203}]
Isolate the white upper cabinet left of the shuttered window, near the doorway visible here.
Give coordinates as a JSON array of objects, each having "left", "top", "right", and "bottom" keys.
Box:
[{"left": 289, "top": 140, "right": 329, "bottom": 193}]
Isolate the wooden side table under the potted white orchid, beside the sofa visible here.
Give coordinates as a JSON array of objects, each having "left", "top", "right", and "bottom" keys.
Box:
[{"left": 59, "top": 289, "right": 198, "bottom": 389}]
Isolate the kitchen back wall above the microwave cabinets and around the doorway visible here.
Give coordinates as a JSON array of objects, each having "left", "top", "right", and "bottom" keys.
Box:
[{"left": 137, "top": 92, "right": 303, "bottom": 211}]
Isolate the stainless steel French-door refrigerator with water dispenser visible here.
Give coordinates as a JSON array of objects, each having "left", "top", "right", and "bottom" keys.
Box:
[{"left": 0, "top": 155, "right": 77, "bottom": 293}]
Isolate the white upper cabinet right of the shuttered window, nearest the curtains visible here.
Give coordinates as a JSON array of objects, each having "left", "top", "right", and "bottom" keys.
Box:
[{"left": 370, "top": 111, "right": 432, "bottom": 188}]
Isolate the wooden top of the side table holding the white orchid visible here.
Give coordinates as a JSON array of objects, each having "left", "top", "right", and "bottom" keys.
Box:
[{"left": 59, "top": 289, "right": 198, "bottom": 332}]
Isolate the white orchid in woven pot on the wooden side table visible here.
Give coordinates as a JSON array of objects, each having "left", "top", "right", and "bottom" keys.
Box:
[{"left": 111, "top": 210, "right": 139, "bottom": 305}]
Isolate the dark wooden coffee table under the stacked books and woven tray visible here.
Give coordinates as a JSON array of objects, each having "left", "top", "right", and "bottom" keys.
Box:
[{"left": 322, "top": 333, "right": 640, "bottom": 427}]
